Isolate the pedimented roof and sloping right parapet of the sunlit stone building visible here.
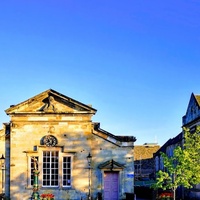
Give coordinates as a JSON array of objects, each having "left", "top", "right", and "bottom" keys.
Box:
[{"left": 5, "top": 89, "right": 136, "bottom": 147}]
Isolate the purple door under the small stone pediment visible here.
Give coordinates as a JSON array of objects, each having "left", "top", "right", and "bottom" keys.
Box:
[{"left": 104, "top": 172, "right": 119, "bottom": 200}]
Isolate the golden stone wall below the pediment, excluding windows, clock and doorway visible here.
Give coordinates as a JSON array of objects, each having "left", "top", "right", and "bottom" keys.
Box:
[{"left": 7, "top": 118, "right": 133, "bottom": 199}]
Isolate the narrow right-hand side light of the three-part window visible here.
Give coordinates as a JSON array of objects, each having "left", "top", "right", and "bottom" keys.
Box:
[{"left": 62, "top": 157, "right": 71, "bottom": 186}]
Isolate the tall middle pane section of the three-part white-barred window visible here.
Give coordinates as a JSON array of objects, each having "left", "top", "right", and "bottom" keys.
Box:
[{"left": 42, "top": 151, "right": 59, "bottom": 187}]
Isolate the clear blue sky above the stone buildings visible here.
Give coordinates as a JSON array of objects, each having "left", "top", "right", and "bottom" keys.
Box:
[{"left": 0, "top": 0, "right": 200, "bottom": 145}]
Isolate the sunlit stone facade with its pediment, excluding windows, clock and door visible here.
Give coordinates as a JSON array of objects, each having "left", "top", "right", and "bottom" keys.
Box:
[{"left": 0, "top": 90, "right": 134, "bottom": 200}]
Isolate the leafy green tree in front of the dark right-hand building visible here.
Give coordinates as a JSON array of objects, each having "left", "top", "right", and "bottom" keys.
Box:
[{"left": 152, "top": 126, "right": 200, "bottom": 200}]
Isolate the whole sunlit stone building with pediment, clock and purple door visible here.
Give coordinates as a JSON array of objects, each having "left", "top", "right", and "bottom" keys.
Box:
[{"left": 0, "top": 89, "right": 136, "bottom": 200}]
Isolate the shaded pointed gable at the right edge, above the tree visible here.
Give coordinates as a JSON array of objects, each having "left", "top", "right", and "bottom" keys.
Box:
[{"left": 183, "top": 93, "right": 200, "bottom": 126}]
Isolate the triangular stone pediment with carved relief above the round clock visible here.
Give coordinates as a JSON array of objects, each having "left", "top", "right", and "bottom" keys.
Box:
[{"left": 5, "top": 89, "right": 96, "bottom": 115}]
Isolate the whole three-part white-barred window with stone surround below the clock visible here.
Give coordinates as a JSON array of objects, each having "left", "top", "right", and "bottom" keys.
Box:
[{"left": 29, "top": 150, "right": 72, "bottom": 187}]
